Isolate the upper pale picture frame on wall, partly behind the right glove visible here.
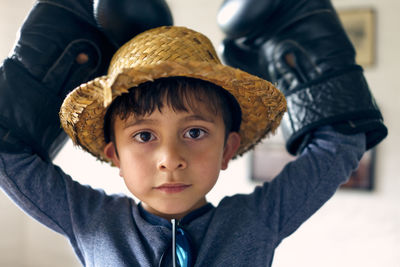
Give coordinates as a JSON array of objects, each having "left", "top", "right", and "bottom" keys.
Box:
[{"left": 337, "top": 7, "right": 376, "bottom": 67}]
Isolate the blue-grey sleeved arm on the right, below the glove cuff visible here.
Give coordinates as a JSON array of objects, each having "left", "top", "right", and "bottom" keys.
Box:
[{"left": 249, "top": 126, "right": 366, "bottom": 240}]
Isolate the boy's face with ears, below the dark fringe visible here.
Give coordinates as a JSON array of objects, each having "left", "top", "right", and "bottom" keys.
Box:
[{"left": 105, "top": 99, "right": 240, "bottom": 219}]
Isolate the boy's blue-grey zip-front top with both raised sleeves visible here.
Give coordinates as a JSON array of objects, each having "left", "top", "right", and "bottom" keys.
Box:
[{"left": 0, "top": 127, "right": 365, "bottom": 267}]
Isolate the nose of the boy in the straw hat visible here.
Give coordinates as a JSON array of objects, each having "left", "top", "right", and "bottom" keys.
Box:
[{"left": 158, "top": 144, "right": 187, "bottom": 171}]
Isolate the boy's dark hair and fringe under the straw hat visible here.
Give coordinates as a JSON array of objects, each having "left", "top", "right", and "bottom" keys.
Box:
[{"left": 104, "top": 77, "right": 242, "bottom": 147}]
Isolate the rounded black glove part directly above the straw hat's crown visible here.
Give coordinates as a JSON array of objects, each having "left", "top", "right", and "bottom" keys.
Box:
[{"left": 94, "top": 0, "right": 173, "bottom": 46}]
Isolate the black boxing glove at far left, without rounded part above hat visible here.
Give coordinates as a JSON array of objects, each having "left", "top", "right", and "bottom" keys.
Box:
[{"left": 0, "top": 0, "right": 116, "bottom": 160}]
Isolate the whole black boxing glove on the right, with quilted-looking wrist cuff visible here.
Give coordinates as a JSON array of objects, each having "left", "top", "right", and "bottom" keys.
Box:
[{"left": 218, "top": 0, "right": 387, "bottom": 154}]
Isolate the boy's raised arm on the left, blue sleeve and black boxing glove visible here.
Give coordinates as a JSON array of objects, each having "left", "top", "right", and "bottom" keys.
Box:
[{"left": 0, "top": 0, "right": 172, "bottom": 262}]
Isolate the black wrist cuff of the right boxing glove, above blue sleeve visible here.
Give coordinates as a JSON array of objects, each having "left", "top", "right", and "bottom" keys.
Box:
[{"left": 281, "top": 68, "right": 387, "bottom": 154}]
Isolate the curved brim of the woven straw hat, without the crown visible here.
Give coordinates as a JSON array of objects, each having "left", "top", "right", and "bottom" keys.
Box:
[{"left": 60, "top": 61, "right": 286, "bottom": 162}]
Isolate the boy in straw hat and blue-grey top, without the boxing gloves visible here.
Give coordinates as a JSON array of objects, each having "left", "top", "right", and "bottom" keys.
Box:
[{"left": 1, "top": 0, "right": 386, "bottom": 266}]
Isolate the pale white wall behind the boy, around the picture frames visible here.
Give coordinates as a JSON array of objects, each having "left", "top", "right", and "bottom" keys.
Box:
[{"left": 0, "top": 0, "right": 400, "bottom": 267}]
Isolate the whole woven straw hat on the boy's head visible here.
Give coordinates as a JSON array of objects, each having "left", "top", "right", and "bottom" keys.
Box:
[{"left": 60, "top": 26, "right": 286, "bottom": 161}]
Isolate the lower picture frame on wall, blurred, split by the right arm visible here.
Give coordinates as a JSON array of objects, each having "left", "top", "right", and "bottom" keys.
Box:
[{"left": 250, "top": 140, "right": 376, "bottom": 191}]
